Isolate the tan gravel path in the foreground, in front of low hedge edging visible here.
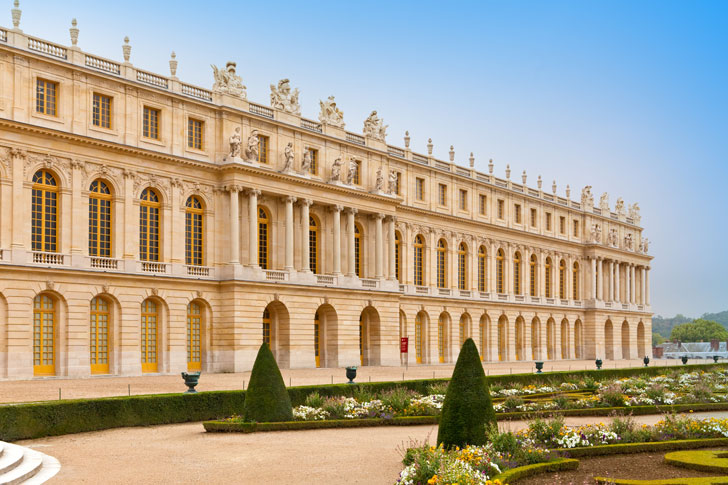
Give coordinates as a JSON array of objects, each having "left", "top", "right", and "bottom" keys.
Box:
[{"left": 19, "top": 412, "right": 728, "bottom": 484}]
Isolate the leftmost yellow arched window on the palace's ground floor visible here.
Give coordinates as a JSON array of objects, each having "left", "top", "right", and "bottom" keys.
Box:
[{"left": 33, "top": 295, "right": 56, "bottom": 376}]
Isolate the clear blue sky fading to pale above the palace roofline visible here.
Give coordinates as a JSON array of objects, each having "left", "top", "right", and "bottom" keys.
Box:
[{"left": 14, "top": 0, "right": 728, "bottom": 316}]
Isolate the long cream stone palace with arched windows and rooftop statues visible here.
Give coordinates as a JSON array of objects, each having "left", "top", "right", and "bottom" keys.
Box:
[{"left": 0, "top": 6, "right": 652, "bottom": 379}]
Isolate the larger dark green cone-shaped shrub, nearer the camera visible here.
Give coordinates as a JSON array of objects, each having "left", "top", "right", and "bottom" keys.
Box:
[{"left": 437, "top": 338, "right": 496, "bottom": 448}]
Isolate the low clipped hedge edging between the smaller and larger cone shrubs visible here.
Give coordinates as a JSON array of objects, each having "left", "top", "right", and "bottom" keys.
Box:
[{"left": 202, "top": 416, "right": 437, "bottom": 433}]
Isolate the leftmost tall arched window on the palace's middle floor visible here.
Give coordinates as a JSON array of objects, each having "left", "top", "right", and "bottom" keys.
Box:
[{"left": 31, "top": 170, "right": 58, "bottom": 253}]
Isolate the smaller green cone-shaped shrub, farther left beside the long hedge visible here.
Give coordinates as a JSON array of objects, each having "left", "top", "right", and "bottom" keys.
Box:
[{"left": 243, "top": 343, "right": 293, "bottom": 423}]
